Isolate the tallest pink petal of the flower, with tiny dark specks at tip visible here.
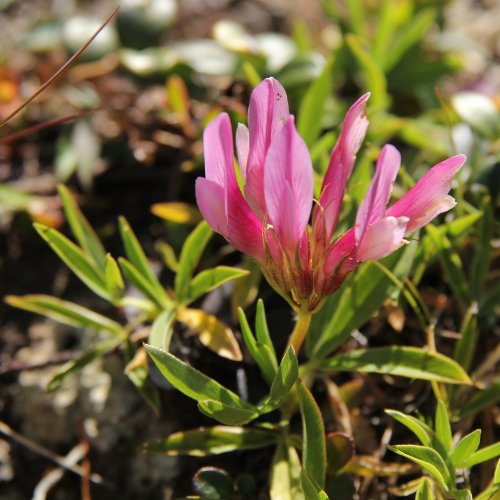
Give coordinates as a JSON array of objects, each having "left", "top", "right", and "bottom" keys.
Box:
[{"left": 245, "top": 78, "right": 290, "bottom": 218}]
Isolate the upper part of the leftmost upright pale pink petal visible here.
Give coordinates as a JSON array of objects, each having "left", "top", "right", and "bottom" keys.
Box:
[{"left": 203, "top": 113, "right": 234, "bottom": 186}]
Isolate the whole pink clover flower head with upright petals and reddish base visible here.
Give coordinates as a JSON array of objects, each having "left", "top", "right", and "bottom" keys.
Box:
[{"left": 196, "top": 78, "right": 465, "bottom": 311}]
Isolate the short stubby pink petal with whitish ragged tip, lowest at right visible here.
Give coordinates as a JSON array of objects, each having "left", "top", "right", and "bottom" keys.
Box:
[{"left": 356, "top": 217, "right": 409, "bottom": 261}]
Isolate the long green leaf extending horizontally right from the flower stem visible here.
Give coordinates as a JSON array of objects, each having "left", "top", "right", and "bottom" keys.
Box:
[{"left": 315, "top": 346, "right": 471, "bottom": 384}]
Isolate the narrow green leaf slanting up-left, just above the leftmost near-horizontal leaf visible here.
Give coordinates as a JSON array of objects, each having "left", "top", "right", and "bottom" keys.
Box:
[{"left": 34, "top": 224, "right": 112, "bottom": 300}]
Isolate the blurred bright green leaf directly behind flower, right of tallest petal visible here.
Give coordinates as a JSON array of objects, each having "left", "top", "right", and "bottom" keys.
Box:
[{"left": 297, "top": 59, "right": 333, "bottom": 147}]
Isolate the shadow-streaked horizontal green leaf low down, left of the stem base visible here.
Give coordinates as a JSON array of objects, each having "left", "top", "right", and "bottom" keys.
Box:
[{"left": 144, "top": 425, "right": 277, "bottom": 457}]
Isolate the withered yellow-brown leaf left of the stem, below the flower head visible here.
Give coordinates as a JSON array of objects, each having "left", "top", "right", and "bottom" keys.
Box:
[{"left": 177, "top": 307, "right": 243, "bottom": 361}]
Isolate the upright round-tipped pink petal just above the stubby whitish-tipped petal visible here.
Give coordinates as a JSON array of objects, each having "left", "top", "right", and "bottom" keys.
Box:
[{"left": 355, "top": 144, "right": 401, "bottom": 242}]
